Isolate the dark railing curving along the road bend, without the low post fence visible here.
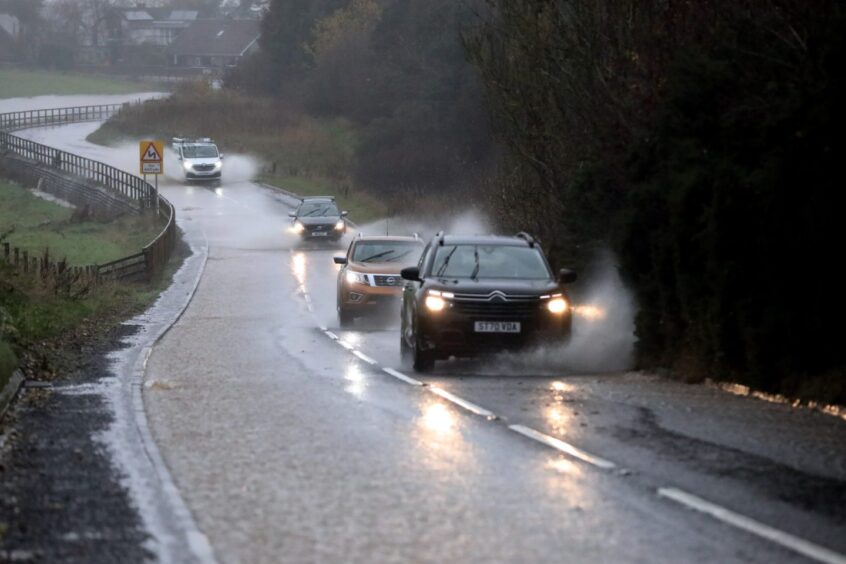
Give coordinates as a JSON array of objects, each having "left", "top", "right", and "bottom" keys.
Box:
[{"left": 0, "top": 104, "right": 176, "bottom": 279}]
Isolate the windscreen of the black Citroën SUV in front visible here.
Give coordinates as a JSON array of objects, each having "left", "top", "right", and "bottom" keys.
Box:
[{"left": 432, "top": 245, "right": 552, "bottom": 280}]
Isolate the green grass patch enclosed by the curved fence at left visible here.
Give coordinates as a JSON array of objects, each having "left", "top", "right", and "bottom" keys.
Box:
[{"left": 0, "top": 179, "right": 161, "bottom": 265}]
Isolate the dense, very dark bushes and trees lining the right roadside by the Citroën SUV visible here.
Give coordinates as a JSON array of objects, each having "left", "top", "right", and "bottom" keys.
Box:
[{"left": 467, "top": 0, "right": 846, "bottom": 402}]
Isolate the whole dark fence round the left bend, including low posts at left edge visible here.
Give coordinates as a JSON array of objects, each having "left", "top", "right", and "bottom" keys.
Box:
[{"left": 0, "top": 104, "right": 176, "bottom": 287}]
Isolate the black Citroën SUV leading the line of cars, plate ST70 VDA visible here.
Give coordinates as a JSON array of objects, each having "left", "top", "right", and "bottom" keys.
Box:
[{"left": 400, "top": 233, "right": 576, "bottom": 371}]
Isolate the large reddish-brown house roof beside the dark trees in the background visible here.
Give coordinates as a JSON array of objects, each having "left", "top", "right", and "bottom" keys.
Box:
[{"left": 171, "top": 20, "right": 260, "bottom": 56}]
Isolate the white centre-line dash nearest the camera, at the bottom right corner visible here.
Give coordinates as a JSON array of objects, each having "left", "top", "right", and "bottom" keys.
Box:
[{"left": 658, "top": 488, "right": 846, "bottom": 564}]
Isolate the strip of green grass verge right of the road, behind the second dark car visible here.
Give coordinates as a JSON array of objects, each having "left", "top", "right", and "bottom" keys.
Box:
[{"left": 261, "top": 175, "right": 388, "bottom": 224}]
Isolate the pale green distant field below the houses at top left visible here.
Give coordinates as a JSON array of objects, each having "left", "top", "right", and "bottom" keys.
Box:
[{"left": 0, "top": 69, "right": 160, "bottom": 99}]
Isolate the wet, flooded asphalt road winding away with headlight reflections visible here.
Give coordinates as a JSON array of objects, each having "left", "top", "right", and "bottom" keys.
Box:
[{"left": 11, "top": 106, "right": 846, "bottom": 562}]
